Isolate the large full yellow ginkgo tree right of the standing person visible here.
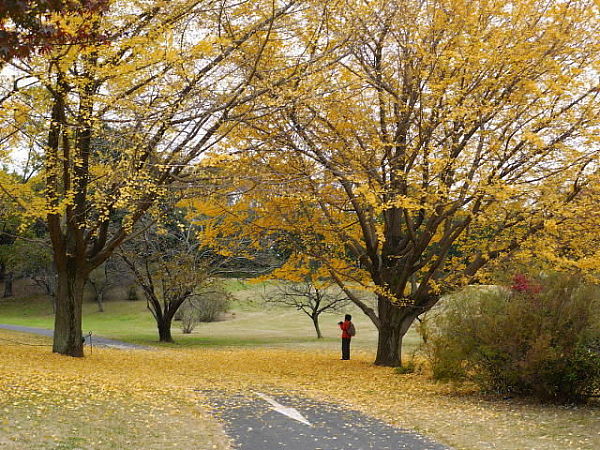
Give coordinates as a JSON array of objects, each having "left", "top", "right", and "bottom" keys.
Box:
[{"left": 206, "top": 0, "right": 600, "bottom": 366}]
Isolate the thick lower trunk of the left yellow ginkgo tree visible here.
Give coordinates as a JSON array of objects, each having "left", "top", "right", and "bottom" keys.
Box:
[{"left": 52, "top": 269, "right": 86, "bottom": 357}]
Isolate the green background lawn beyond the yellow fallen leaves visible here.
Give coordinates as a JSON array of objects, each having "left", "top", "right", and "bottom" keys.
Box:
[{"left": 0, "top": 279, "right": 420, "bottom": 357}]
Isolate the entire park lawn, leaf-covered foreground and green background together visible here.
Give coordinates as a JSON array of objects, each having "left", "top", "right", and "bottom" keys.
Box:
[{"left": 0, "top": 280, "right": 600, "bottom": 449}]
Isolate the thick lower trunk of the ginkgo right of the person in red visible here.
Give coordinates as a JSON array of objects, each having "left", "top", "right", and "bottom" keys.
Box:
[{"left": 375, "top": 297, "right": 417, "bottom": 367}]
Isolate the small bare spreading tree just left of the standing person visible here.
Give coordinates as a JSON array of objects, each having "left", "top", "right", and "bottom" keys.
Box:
[{"left": 264, "top": 278, "right": 350, "bottom": 339}]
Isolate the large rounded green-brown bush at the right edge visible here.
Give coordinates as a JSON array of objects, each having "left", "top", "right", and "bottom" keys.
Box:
[{"left": 425, "top": 275, "right": 600, "bottom": 403}]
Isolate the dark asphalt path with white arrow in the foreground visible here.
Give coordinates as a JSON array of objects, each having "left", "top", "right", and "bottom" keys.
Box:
[{"left": 202, "top": 391, "right": 449, "bottom": 450}]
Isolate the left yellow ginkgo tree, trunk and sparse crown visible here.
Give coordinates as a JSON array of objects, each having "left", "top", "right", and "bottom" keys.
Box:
[{"left": 0, "top": 0, "right": 338, "bottom": 356}]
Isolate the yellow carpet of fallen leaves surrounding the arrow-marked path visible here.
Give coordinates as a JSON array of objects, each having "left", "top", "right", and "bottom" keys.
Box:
[{"left": 0, "top": 328, "right": 600, "bottom": 449}]
